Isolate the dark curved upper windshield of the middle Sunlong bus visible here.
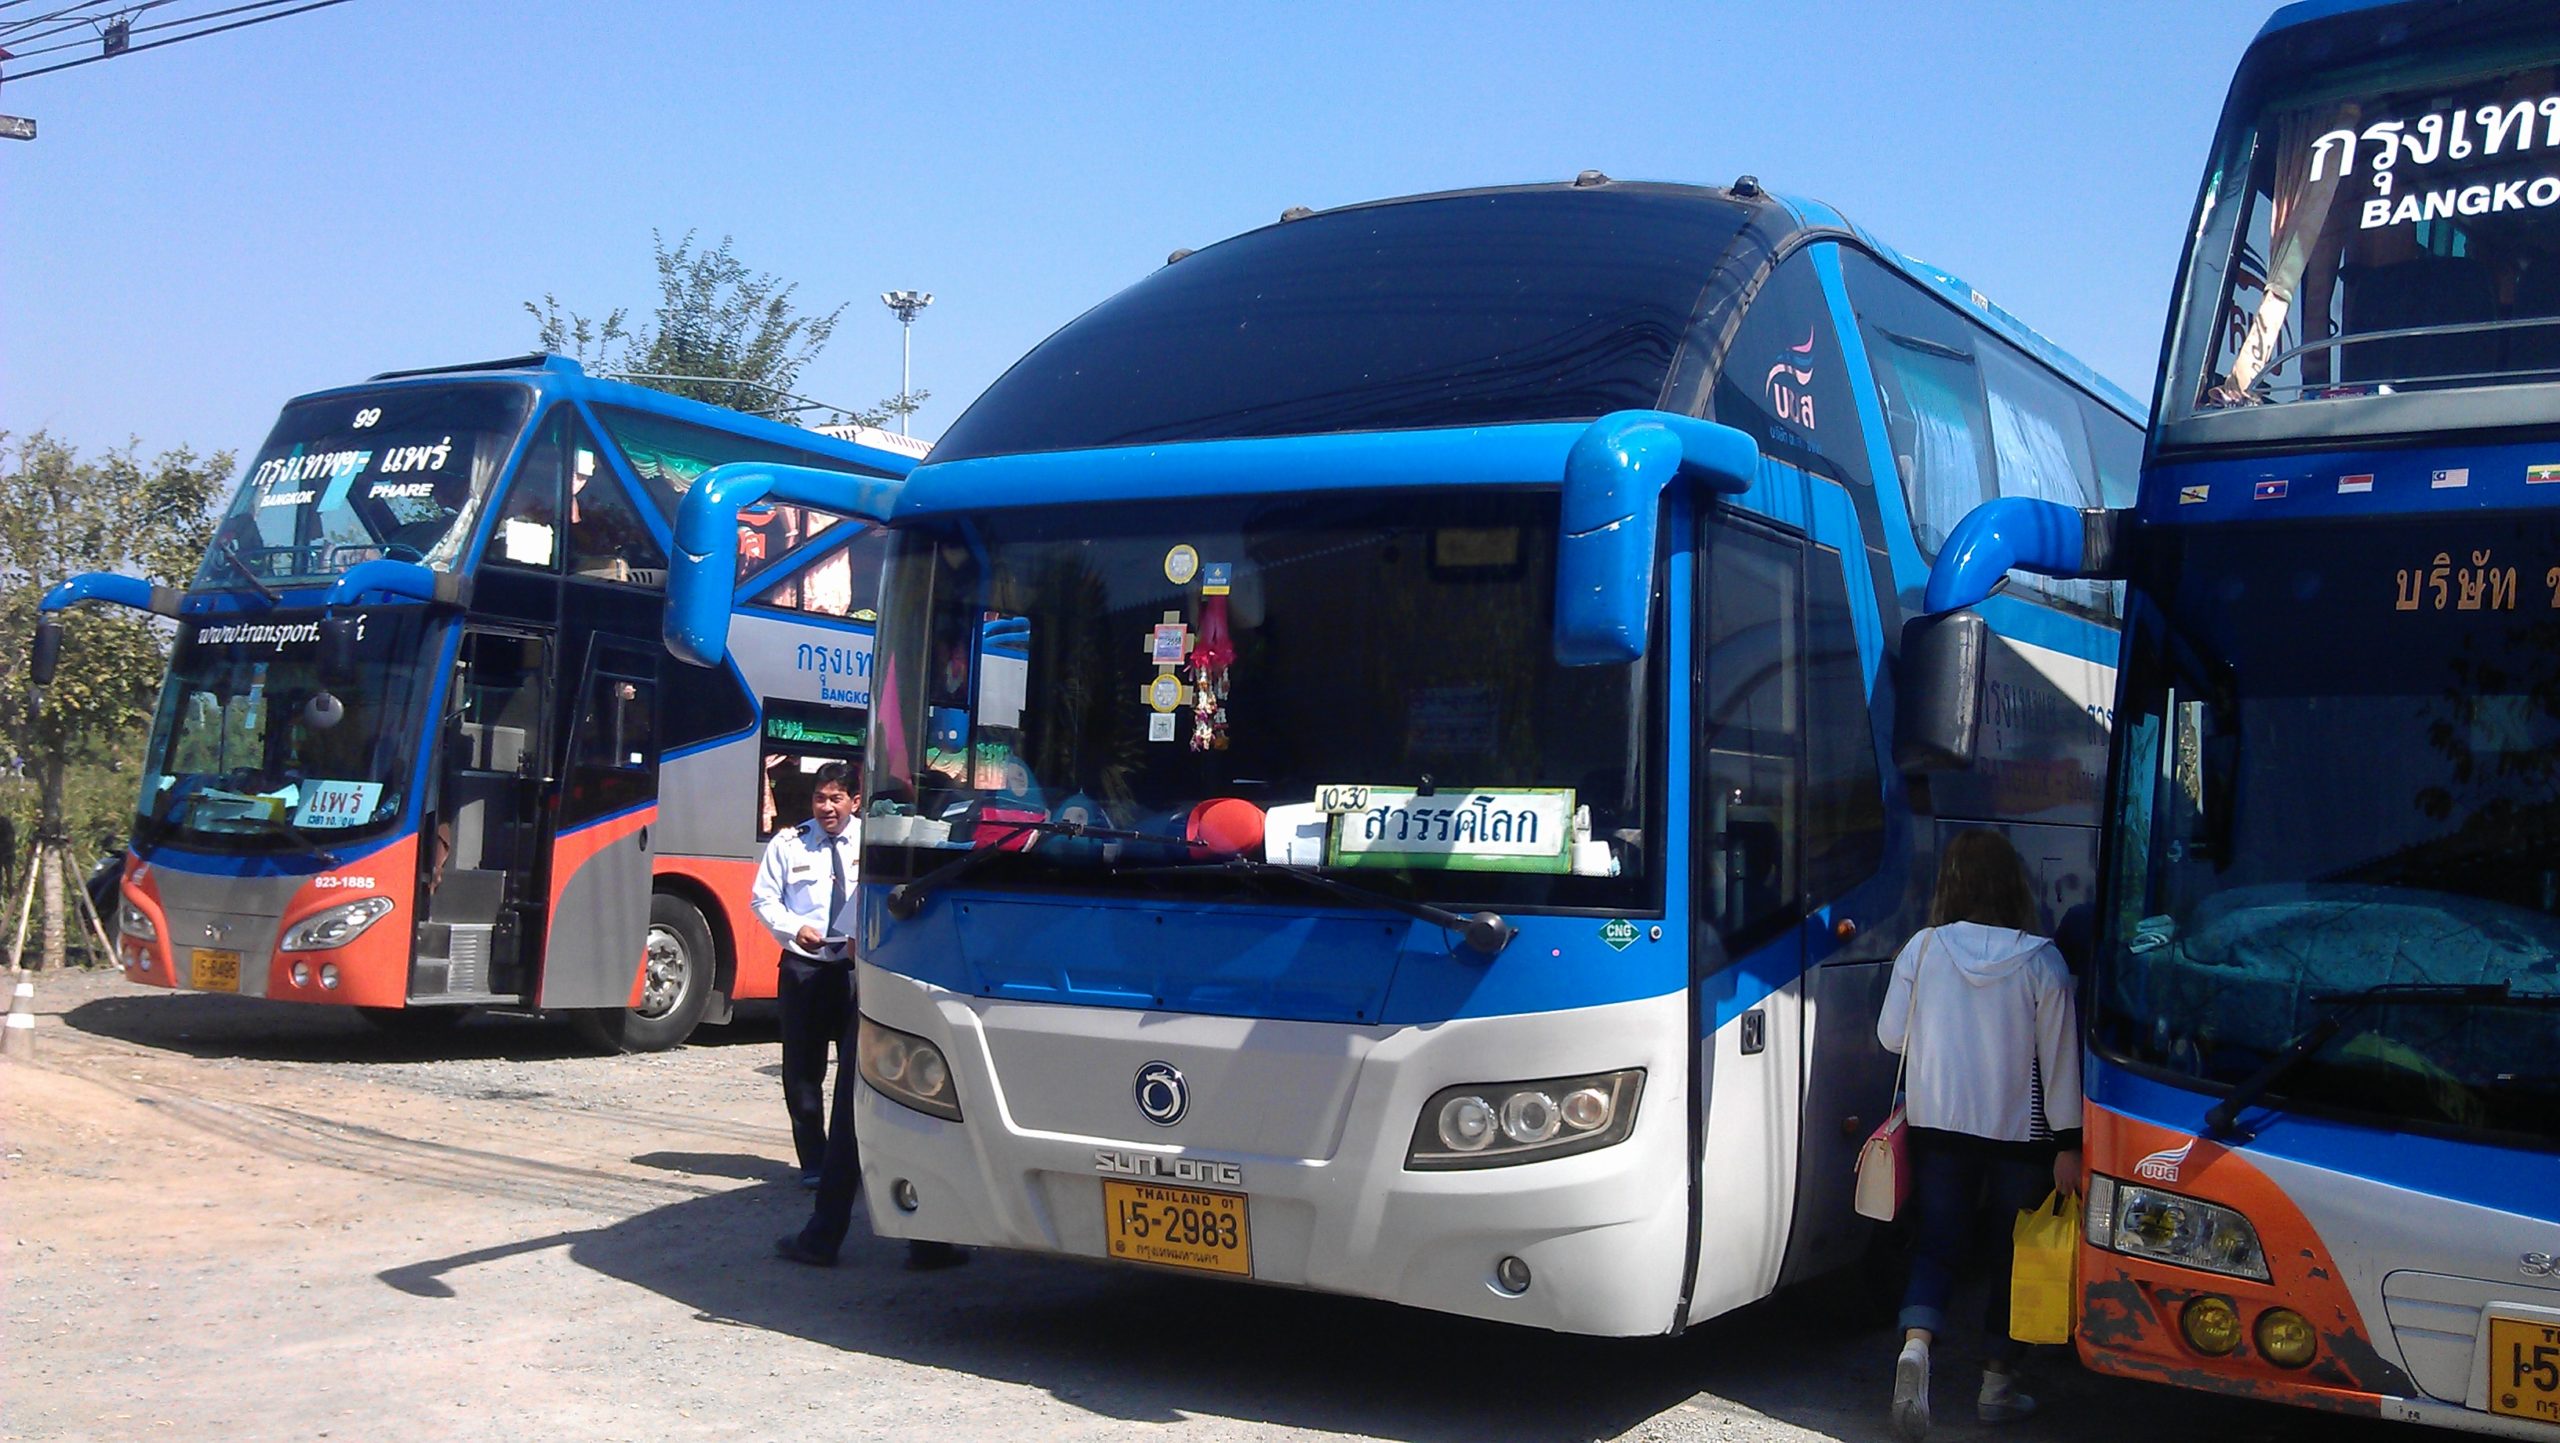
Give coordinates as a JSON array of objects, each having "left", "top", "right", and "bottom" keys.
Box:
[{"left": 934, "top": 187, "right": 1748, "bottom": 461}]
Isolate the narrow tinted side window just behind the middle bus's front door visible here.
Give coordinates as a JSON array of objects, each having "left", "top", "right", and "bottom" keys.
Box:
[{"left": 1805, "top": 545, "right": 1884, "bottom": 906}]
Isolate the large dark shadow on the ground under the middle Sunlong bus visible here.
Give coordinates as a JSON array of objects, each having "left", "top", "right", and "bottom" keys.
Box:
[{"left": 379, "top": 1171, "right": 2363, "bottom": 1443}]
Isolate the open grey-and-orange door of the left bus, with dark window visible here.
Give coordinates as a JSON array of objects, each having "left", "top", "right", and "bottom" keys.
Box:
[{"left": 540, "top": 632, "right": 666, "bottom": 1008}]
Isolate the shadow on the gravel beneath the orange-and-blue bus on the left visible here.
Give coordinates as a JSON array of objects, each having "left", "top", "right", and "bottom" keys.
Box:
[{"left": 61, "top": 993, "right": 781, "bottom": 1062}]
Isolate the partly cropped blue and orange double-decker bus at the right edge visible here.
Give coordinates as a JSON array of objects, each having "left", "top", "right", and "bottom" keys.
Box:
[{"left": 1915, "top": 0, "right": 2560, "bottom": 1438}]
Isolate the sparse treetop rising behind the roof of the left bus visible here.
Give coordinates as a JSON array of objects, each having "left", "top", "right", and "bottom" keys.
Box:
[{"left": 525, "top": 230, "right": 924, "bottom": 425}]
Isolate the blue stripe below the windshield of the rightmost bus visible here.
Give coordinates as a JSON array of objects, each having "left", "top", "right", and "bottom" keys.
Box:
[{"left": 2084, "top": 1057, "right": 2560, "bottom": 1218}]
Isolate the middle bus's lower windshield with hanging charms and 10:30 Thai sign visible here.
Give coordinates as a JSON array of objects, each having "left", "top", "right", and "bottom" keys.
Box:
[{"left": 865, "top": 491, "right": 1654, "bottom": 908}]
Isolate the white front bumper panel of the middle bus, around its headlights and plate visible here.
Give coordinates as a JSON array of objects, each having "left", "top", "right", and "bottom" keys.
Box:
[{"left": 858, "top": 965, "right": 1690, "bottom": 1336}]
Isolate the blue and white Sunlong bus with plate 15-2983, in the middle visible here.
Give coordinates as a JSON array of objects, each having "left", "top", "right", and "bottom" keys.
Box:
[{"left": 668, "top": 174, "right": 2138, "bottom": 1336}]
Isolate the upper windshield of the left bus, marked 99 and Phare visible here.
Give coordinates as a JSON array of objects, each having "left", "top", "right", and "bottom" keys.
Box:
[{"left": 195, "top": 384, "right": 532, "bottom": 591}]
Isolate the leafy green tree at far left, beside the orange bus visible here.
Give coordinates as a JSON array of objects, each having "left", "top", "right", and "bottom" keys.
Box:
[{"left": 0, "top": 432, "right": 233, "bottom": 967}]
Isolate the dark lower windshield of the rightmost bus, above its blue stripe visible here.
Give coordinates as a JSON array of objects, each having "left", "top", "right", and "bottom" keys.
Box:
[{"left": 2097, "top": 517, "right": 2560, "bottom": 1144}]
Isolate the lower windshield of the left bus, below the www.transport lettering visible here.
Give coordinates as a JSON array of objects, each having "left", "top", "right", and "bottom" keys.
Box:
[{"left": 136, "top": 606, "right": 435, "bottom": 852}]
